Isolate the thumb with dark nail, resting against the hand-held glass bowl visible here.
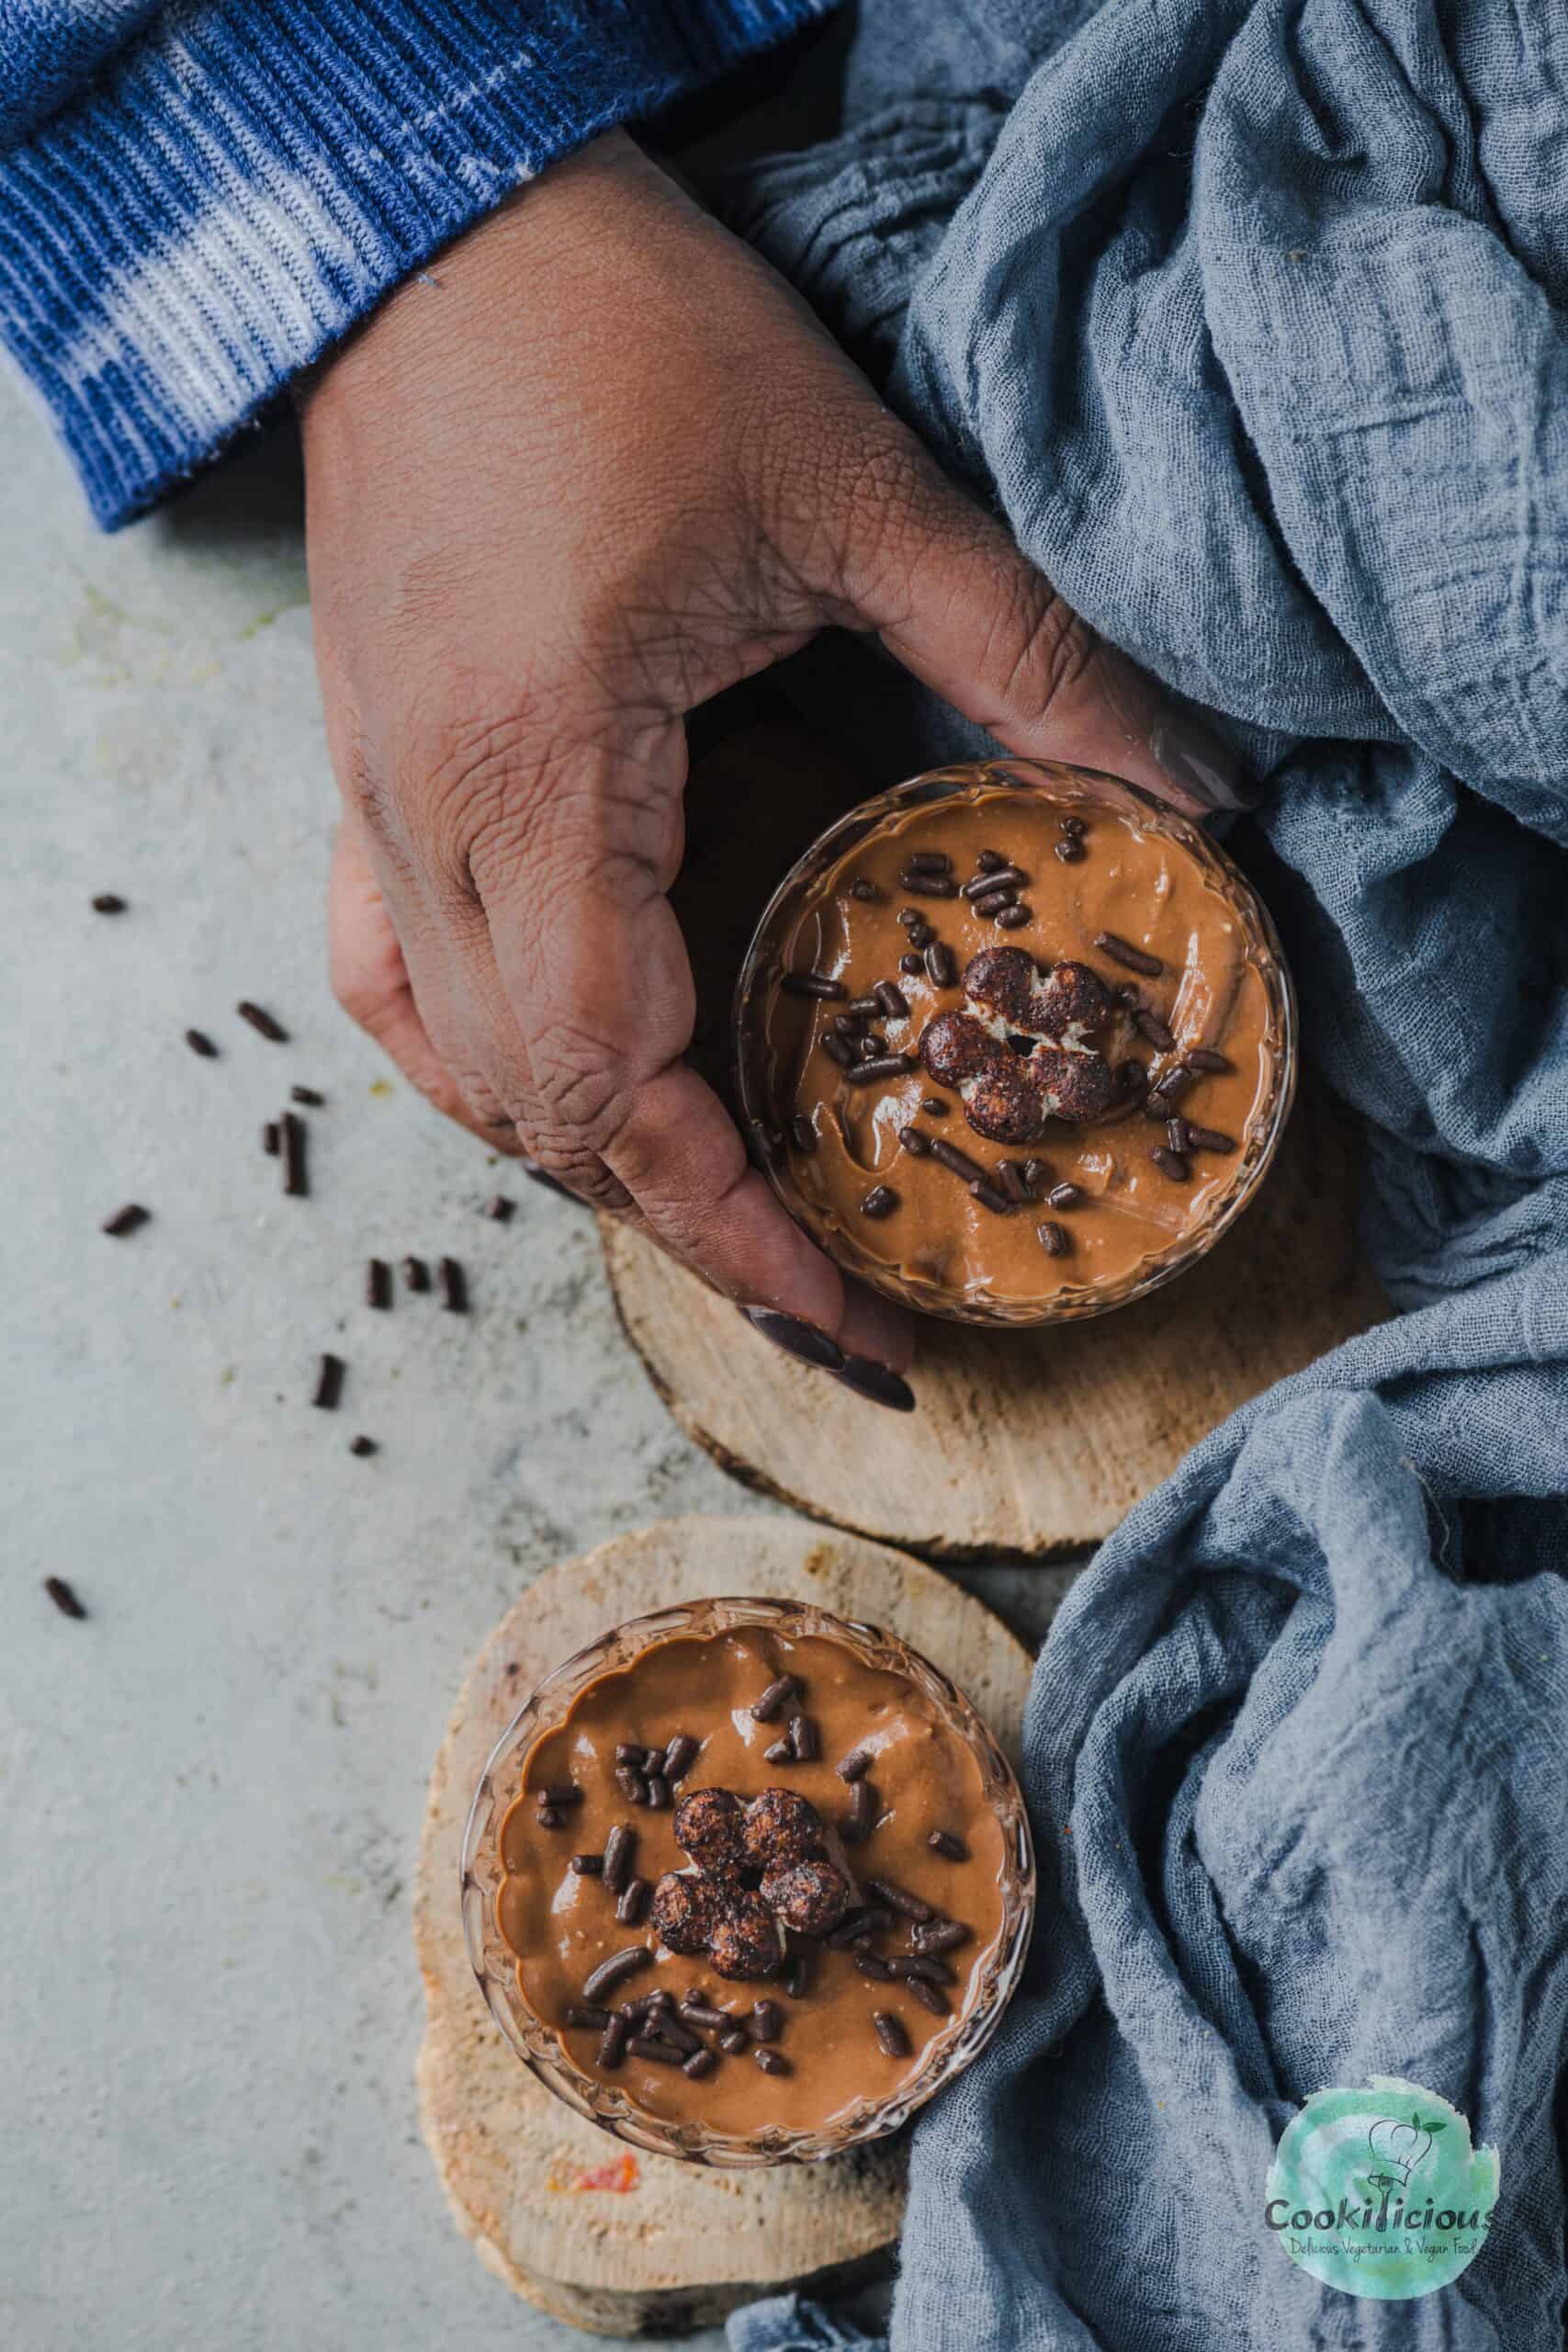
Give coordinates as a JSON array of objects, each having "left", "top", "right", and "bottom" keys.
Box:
[{"left": 841, "top": 425, "right": 1256, "bottom": 816}]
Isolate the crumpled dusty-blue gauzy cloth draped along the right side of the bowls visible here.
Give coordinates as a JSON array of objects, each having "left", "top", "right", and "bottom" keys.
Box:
[{"left": 722, "top": 0, "right": 1568, "bottom": 2352}]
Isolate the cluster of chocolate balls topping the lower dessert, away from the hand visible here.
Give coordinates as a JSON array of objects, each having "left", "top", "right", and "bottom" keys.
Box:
[{"left": 653, "top": 1788, "right": 851, "bottom": 1981}]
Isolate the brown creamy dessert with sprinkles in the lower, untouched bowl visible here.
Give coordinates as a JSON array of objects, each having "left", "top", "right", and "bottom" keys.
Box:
[{"left": 496, "top": 1628, "right": 1006, "bottom": 2135}]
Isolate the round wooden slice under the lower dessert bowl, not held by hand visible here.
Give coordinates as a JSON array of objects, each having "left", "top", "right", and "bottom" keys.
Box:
[{"left": 413, "top": 1515, "right": 1030, "bottom": 2335}]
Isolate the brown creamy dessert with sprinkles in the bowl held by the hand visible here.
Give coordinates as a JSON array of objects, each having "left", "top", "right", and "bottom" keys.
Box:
[{"left": 761, "top": 786, "right": 1283, "bottom": 1301}]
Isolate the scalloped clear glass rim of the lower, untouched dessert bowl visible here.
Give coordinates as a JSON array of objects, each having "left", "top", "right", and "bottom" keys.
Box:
[{"left": 461, "top": 1597, "right": 1034, "bottom": 2168}]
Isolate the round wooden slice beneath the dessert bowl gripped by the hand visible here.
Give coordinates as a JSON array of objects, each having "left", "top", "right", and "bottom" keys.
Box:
[{"left": 602, "top": 1093, "right": 1389, "bottom": 1559}]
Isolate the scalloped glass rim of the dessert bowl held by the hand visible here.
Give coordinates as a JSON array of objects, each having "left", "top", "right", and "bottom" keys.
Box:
[{"left": 731, "top": 760, "right": 1298, "bottom": 1329}]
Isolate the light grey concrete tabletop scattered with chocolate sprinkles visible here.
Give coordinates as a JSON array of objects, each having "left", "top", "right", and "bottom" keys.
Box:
[{"left": 0, "top": 383, "right": 1058, "bottom": 2352}]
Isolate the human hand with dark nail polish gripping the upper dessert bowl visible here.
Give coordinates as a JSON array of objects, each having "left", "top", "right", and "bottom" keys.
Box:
[{"left": 301, "top": 134, "right": 1229, "bottom": 1404}]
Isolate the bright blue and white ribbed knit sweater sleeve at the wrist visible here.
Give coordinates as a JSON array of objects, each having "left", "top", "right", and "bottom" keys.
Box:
[{"left": 0, "top": 0, "right": 828, "bottom": 526}]
